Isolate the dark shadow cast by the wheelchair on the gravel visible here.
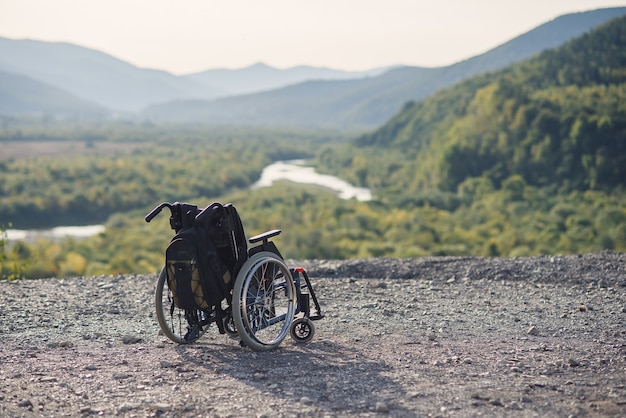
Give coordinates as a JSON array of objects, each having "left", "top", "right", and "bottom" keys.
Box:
[{"left": 176, "top": 336, "right": 417, "bottom": 417}]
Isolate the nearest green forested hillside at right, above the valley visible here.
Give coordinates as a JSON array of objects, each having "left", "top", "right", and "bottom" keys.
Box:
[{"left": 346, "top": 16, "right": 626, "bottom": 198}]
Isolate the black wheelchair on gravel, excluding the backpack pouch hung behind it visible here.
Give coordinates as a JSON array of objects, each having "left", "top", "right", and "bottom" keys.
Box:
[{"left": 145, "top": 202, "right": 324, "bottom": 351}]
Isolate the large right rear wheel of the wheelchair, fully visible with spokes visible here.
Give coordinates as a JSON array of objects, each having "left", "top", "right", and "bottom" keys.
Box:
[{"left": 233, "top": 251, "right": 296, "bottom": 351}]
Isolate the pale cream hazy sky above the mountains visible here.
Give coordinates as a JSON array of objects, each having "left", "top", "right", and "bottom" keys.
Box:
[{"left": 0, "top": 0, "right": 626, "bottom": 74}]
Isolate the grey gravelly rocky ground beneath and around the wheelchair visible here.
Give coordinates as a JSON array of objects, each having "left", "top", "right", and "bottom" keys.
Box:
[{"left": 0, "top": 252, "right": 626, "bottom": 417}]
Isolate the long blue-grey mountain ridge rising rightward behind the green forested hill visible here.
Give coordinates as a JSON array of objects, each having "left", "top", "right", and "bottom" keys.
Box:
[{"left": 143, "top": 7, "right": 626, "bottom": 129}]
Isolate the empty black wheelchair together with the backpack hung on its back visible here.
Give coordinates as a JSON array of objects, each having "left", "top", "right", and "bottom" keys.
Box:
[{"left": 145, "top": 202, "right": 323, "bottom": 351}]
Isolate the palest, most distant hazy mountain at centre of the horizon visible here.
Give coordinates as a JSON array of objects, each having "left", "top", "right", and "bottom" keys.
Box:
[{"left": 183, "top": 63, "right": 388, "bottom": 96}]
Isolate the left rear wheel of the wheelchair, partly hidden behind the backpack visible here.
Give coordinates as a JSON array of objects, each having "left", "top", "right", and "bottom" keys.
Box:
[{"left": 154, "top": 268, "right": 209, "bottom": 344}]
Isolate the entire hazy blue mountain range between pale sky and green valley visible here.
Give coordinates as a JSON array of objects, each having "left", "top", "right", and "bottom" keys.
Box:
[{"left": 0, "top": 7, "right": 626, "bottom": 130}]
